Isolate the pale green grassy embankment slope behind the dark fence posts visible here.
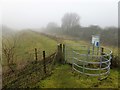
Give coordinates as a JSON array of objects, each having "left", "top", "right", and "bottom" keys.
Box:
[{"left": 2, "top": 30, "right": 57, "bottom": 67}]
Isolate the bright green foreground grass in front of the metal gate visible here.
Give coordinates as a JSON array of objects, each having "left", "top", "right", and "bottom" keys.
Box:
[{"left": 36, "top": 65, "right": 118, "bottom": 88}]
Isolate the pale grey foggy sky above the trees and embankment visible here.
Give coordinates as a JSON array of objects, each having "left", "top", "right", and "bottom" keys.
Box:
[{"left": 0, "top": 0, "right": 119, "bottom": 29}]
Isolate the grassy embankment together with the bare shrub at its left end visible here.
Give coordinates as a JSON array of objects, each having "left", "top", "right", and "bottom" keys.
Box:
[{"left": 2, "top": 31, "right": 57, "bottom": 72}]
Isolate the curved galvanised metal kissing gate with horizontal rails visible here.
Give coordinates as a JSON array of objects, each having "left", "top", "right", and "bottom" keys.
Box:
[{"left": 65, "top": 44, "right": 112, "bottom": 79}]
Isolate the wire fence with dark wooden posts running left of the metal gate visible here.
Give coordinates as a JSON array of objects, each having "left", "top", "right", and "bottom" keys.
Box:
[{"left": 3, "top": 48, "right": 56, "bottom": 88}]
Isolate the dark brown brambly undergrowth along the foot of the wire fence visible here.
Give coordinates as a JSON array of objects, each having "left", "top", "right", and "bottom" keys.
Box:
[{"left": 2, "top": 54, "right": 54, "bottom": 89}]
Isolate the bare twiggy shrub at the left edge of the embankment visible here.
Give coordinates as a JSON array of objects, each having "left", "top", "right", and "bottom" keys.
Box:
[{"left": 2, "top": 36, "right": 18, "bottom": 72}]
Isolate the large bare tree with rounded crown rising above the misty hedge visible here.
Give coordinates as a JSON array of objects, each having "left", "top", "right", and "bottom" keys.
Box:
[{"left": 62, "top": 13, "right": 80, "bottom": 29}]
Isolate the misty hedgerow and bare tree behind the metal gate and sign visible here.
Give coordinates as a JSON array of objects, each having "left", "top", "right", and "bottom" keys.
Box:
[{"left": 44, "top": 13, "right": 120, "bottom": 67}]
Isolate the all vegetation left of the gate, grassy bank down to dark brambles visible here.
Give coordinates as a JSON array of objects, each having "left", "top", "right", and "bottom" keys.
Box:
[{"left": 2, "top": 30, "right": 57, "bottom": 89}]
